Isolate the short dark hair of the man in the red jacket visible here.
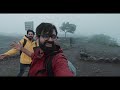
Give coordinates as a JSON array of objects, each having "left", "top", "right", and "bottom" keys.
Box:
[{"left": 36, "top": 23, "right": 58, "bottom": 37}]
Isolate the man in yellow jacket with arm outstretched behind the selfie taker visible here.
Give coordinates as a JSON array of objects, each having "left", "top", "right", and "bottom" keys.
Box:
[{"left": 0, "top": 30, "right": 36, "bottom": 76}]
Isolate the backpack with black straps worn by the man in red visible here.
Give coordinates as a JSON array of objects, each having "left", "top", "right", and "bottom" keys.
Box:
[{"left": 28, "top": 51, "right": 76, "bottom": 77}]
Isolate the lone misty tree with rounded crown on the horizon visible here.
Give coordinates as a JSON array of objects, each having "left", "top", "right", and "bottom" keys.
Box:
[{"left": 59, "top": 22, "right": 76, "bottom": 38}]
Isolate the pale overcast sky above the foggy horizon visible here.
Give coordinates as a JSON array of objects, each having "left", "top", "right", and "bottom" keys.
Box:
[{"left": 0, "top": 13, "right": 120, "bottom": 39}]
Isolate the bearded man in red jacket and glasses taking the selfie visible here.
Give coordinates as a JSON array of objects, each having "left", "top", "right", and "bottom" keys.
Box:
[{"left": 12, "top": 23, "right": 74, "bottom": 76}]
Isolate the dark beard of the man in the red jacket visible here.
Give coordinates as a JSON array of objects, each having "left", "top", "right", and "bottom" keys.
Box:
[{"left": 40, "top": 41, "right": 56, "bottom": 54}]
